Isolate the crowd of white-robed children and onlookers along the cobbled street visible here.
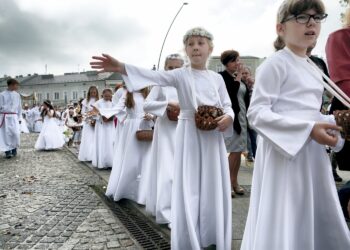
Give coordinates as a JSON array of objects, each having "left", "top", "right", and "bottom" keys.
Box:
[{"left": 0, "top": 0, "right": 350, "bottom": 250}]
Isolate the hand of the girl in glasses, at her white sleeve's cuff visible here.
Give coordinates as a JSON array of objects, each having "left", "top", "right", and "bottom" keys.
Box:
[{"left": 310, "top": 123, "right": 341, "bottom": 147}]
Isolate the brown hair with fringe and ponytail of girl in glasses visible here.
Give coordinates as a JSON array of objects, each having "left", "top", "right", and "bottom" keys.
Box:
[{"left": 273, "top": 0, "right": 326, "bottom": 51}]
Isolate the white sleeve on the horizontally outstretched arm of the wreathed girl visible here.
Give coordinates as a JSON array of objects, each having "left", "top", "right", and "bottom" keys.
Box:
[{"left": 122, "top": 64, "right": 181, "bottom": 92}]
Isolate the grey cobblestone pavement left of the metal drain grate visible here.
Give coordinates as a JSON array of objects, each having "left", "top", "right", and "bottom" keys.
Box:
[{"left": 0, "top": 134, "right": 140, "bottom": 250}]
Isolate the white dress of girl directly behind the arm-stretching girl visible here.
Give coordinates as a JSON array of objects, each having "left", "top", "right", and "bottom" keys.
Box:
[{"left": 143, "top": 86, "right": 179, "bottom": 224}]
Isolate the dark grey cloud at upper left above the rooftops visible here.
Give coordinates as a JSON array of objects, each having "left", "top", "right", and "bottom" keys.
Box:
[{"left": 0, "top": 0, "right": 143, "bottom": 76}]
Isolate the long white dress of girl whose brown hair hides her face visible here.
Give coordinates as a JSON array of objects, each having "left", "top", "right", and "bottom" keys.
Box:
[{"left": 105, "top": 92, "right": 151, "bottom": 204}]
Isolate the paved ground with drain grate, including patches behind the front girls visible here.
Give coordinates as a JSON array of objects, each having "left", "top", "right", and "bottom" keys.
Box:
[{"left": 0, "top": 134, "right": 350, "bottom": 250}]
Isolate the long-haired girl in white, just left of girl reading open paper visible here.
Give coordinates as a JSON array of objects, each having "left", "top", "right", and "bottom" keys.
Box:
[{"left": 78, "top": 86, "right": 98, "bottom": 161}]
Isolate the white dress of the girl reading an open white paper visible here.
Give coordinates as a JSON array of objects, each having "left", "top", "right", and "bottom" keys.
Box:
[{"left": 92, "top": 99, "right": 114, "bottom": 168}]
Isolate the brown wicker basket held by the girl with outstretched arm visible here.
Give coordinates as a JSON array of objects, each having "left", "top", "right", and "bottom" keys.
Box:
[{"left": 195, "top": 105, "right": 224, "bottom": 130}]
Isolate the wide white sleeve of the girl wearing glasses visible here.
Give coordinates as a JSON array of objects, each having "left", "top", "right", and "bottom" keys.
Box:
[{"left": 247, "top": 60, "right": 315, "bottom": 158}]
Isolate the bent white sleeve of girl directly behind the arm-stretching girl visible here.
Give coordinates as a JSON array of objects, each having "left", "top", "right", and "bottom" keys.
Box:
[{"left": 143, "top": 86, "right": 168, "bottom": 117}]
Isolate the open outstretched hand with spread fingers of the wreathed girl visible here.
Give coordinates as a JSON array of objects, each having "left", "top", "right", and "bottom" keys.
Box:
[{"left": 90, "top": 54, "right": 126, "bottom": 75}]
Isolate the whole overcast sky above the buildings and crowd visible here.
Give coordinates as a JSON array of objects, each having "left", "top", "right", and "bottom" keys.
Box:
[{"left": 0, "top": 0, "right": 344, "bottom": 77}]
